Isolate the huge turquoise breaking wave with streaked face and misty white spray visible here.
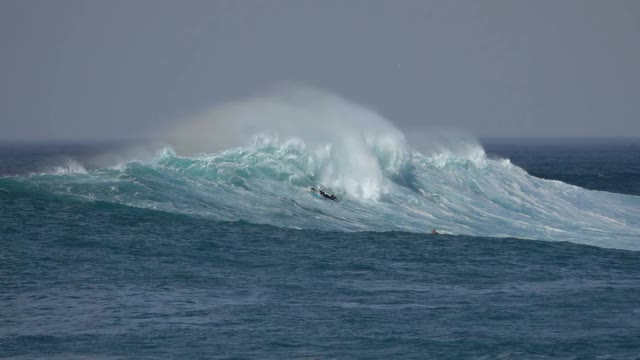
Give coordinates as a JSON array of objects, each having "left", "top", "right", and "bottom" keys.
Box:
[{"left": 0, "top": 89, "right": 640, "bottom": 250}]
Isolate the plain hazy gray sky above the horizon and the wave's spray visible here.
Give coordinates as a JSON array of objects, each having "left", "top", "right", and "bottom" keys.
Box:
[{"left": 0, "top": 0, "right": 640, "bottom": 140}]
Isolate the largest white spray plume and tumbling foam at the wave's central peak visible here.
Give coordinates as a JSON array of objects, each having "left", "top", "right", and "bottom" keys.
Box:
[{"left": 171, "top": 88, "right": 407, "bottom": 200}]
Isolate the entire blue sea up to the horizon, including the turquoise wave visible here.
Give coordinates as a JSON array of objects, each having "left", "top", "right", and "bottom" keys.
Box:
[{"left": 0, "top": 139, "right": 640, "bottom": 359}]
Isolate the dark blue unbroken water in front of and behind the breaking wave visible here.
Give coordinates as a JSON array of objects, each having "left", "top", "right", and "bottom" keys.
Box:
[{"left": 0, "top": 144, "right": 640, "bottom": 359}]
